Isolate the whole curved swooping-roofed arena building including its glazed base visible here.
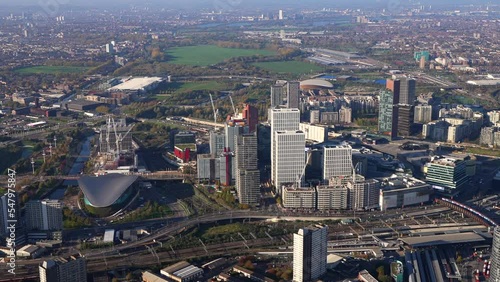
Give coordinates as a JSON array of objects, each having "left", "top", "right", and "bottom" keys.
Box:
[{"left": 78, "top": 174, "right": 138, "bottom": 217}]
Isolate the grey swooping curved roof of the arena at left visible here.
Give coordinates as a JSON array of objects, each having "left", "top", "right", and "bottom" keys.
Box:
[{"left": 78, "top": 173, "right": 138, "bottom": 208}]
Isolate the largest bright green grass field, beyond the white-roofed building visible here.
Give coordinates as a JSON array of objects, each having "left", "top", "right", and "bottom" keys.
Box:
[{"left": 166, "top": 45, "right": 276, "bottom": 66}]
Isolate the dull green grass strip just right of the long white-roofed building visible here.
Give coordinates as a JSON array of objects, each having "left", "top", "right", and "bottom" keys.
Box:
[{"left": 156, "top": 80, "right": 230, "bottom": 100}]
